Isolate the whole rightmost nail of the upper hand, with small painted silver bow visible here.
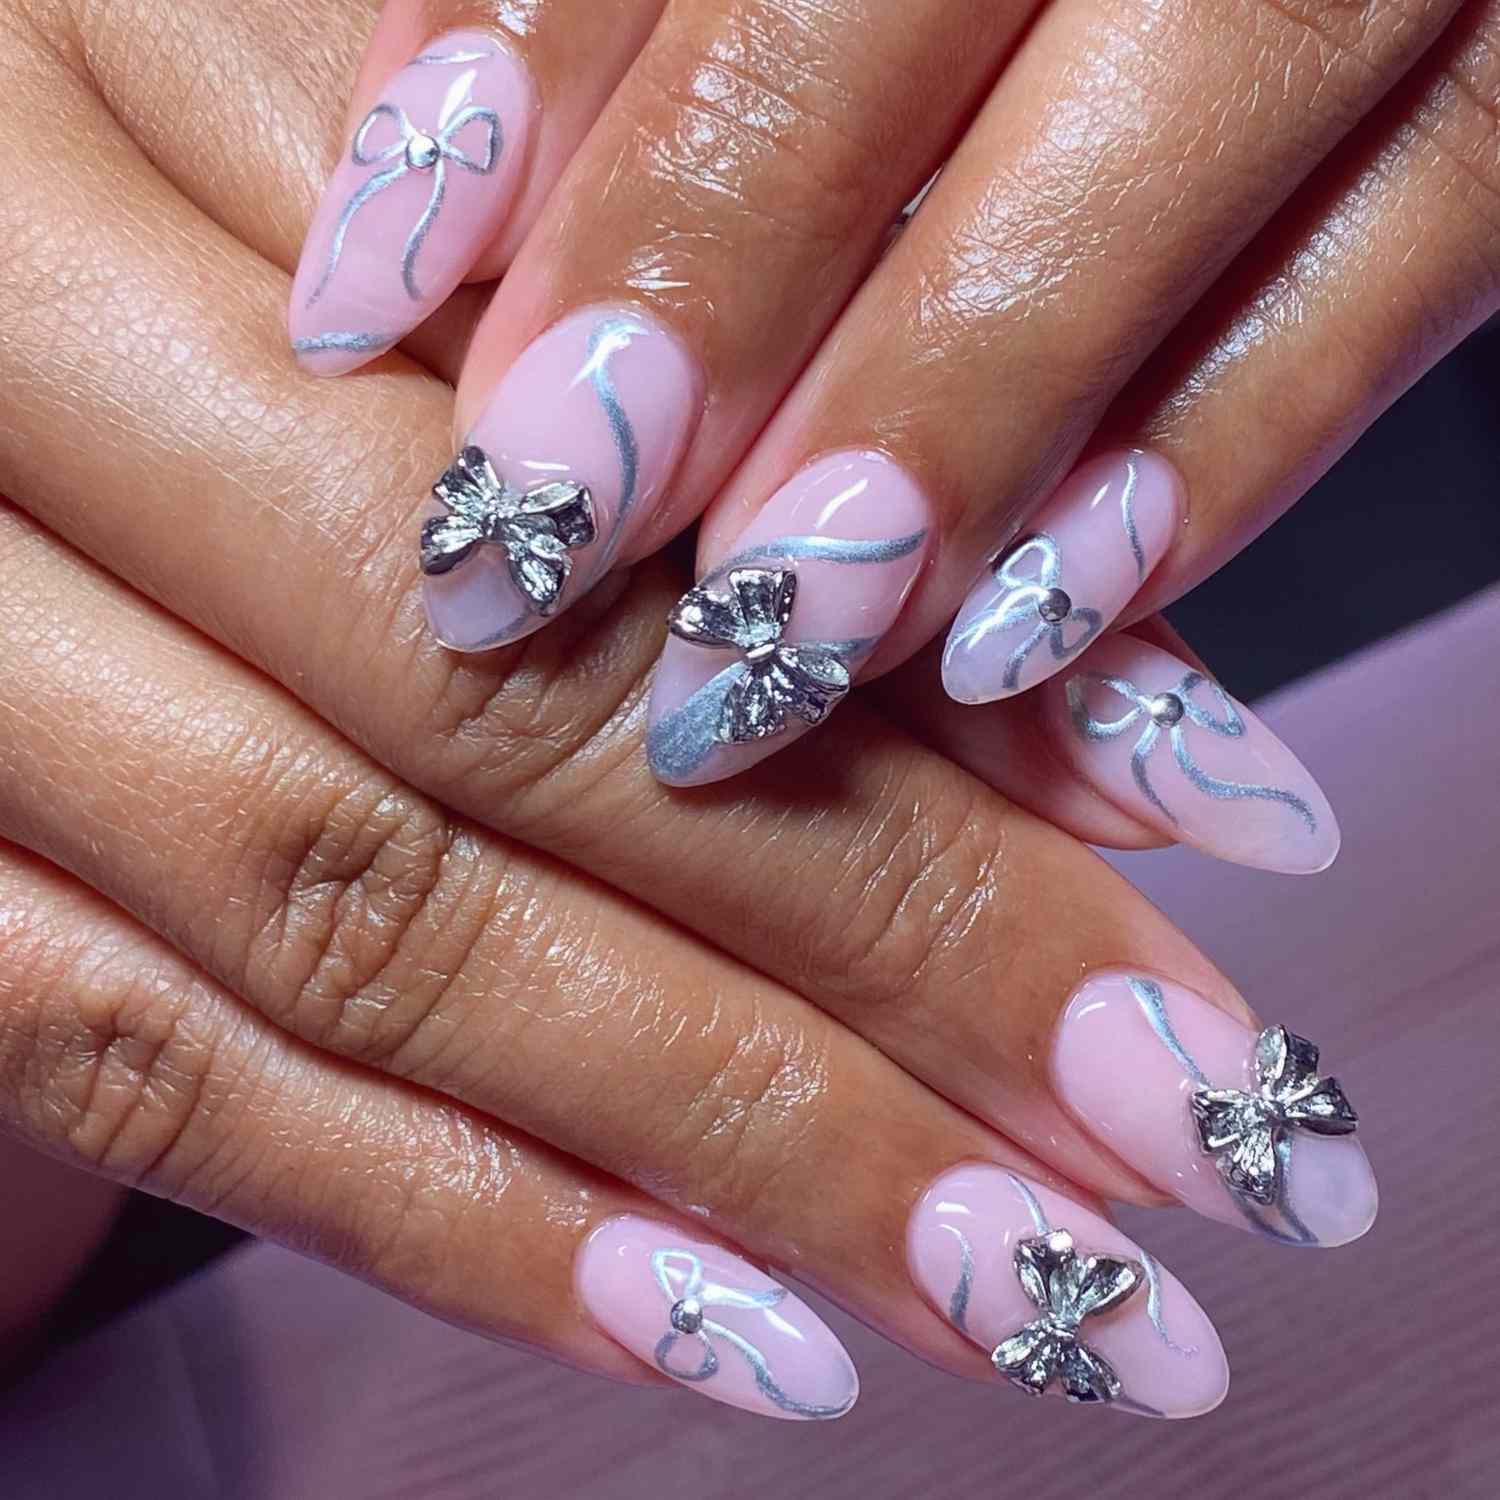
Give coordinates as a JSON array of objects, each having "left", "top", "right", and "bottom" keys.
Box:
[{"left": 942, "top": 449, "right": 1182, "bottom": 704}]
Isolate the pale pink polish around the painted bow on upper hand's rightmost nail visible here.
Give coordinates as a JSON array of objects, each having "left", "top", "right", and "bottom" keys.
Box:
[{"left": 942, "top": 449, "right": 1184, "bottom": 704}]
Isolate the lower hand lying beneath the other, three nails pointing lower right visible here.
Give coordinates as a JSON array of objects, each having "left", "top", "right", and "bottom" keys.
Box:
[{"left": 0, "top": 0, "right": 1374, "bottom": 1416}]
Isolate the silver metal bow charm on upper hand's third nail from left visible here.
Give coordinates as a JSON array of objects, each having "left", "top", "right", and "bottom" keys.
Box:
[{"left": 668, "top": 567, "right": 851, "bottom": 744}]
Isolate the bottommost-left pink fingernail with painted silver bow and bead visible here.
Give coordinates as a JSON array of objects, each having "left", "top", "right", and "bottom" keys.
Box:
[{"left": 575, "top": 1215, "right": 860, "bottom": 1422}]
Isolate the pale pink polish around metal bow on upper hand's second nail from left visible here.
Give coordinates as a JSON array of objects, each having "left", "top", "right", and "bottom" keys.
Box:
[{"left": 423, "top": 306, "right": 702, "bottom": 651}]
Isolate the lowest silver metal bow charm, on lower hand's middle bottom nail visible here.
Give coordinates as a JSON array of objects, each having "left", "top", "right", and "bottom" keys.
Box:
[{"left": 990, "top": 1230, "right": 1146, "bottom": 1403}]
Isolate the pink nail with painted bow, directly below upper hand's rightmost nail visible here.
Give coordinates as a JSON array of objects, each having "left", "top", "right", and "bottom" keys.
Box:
[{"left": 1043, "top": 635, "right": 1340, "bottom": 875}]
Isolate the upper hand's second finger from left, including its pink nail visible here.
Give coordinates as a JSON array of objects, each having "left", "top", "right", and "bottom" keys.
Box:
[{"left": 423, "top": 0, "right": 1034, "bottom": 651}]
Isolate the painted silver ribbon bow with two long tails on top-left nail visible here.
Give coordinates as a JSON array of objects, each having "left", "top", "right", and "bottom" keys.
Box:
[{"left": 308, "top": 93, "right": 501, "bottom": 308}]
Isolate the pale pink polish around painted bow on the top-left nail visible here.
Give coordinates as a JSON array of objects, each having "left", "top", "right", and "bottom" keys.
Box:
[{"left": 288, "top": 32, "right": 536, "bottom": 375}]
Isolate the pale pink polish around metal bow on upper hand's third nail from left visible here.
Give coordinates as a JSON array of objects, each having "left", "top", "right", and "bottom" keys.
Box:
[{"left": 648, "top": 452, "right": 933, "bottom": 786}]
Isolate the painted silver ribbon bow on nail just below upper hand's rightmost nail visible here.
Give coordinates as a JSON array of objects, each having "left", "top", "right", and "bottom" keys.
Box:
[{"left": 1067, "top": 672, "right": 1317, "bottom": 834}]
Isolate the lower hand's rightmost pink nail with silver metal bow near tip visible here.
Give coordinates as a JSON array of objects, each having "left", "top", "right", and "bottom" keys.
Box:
[{"left": 1052, "top": 974, "right": 1379, "bottom": 1248}]
